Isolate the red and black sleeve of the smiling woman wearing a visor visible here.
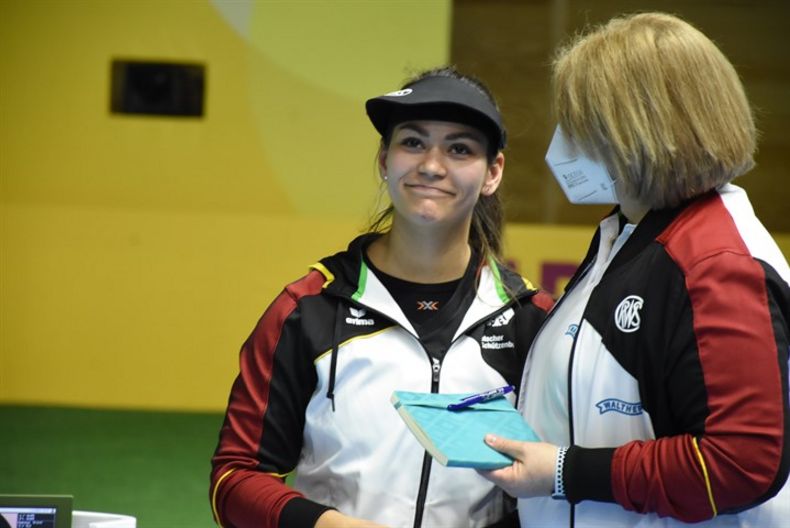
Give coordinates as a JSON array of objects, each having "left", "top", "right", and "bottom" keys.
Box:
[{"left": 210, "top": 272, "right": 324, "bottom": 528}]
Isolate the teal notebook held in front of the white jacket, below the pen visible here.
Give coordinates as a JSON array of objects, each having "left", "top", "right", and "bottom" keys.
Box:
[{"left": 390, "top": 391, "right": 539, "bottom": 469}]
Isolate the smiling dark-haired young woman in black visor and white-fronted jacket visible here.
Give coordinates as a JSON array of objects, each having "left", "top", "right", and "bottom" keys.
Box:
[{"left": 211, "top": 69, "right": 551, "bottom": 528}]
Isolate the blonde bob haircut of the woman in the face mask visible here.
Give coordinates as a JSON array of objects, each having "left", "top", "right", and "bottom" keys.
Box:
[{"left": 553, "top": 13, "right": 757, "bottom": 209}]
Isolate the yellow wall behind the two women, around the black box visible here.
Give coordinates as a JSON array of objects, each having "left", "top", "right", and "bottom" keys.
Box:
[{"left": 0, "top": 0, "right": 790, "bottom": 410}]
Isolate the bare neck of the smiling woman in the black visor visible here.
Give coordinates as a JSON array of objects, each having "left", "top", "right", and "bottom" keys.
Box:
[{"left": 368, "top": 218, "right": 472, "bottom": 284}]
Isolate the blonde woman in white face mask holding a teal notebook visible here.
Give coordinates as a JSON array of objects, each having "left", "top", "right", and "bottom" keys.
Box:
[{"left": 484, "top": 13, "right": 790, "bottom": 527}]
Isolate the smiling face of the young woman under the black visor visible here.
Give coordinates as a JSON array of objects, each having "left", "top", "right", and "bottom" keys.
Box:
[{"left": 379, "top": 121, "right": 504, "bottom": 233}]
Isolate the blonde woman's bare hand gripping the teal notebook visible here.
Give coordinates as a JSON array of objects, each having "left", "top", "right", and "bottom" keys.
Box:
[{"left": 478, "top": 435, "right": 559, "bottom": 497}]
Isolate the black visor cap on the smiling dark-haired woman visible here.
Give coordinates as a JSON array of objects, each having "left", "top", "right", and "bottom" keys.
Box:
[{"left": 365, "top": 76, "right": 507, "bottom": 150}]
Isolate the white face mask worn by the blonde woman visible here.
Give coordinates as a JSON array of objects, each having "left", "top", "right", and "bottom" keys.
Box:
[{"left": 546, "top": 126, "right": 617, "bottom": 204}]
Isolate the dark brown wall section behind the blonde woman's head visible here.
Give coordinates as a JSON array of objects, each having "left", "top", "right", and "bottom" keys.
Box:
[{"left": 451, "top": 0, "right": 790, "bottom": 233}]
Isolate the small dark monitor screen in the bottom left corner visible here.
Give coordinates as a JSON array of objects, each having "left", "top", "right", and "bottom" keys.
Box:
[{"left": 0, "top": 495, "right": 73, "bottom": 528}]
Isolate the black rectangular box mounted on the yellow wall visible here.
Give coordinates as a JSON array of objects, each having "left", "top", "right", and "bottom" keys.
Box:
[{"left": 110, "top": 59, "right": 206, "bottom": 117}]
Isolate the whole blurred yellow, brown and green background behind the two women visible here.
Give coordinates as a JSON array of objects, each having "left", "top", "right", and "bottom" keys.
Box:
[{"left": 0, "top": 0, "right": 790, "bottom": 528}]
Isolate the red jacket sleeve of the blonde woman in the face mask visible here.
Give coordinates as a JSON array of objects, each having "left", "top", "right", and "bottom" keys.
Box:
[{"left": 611, "top": 219, "right": 788, "bottom": 522}]
